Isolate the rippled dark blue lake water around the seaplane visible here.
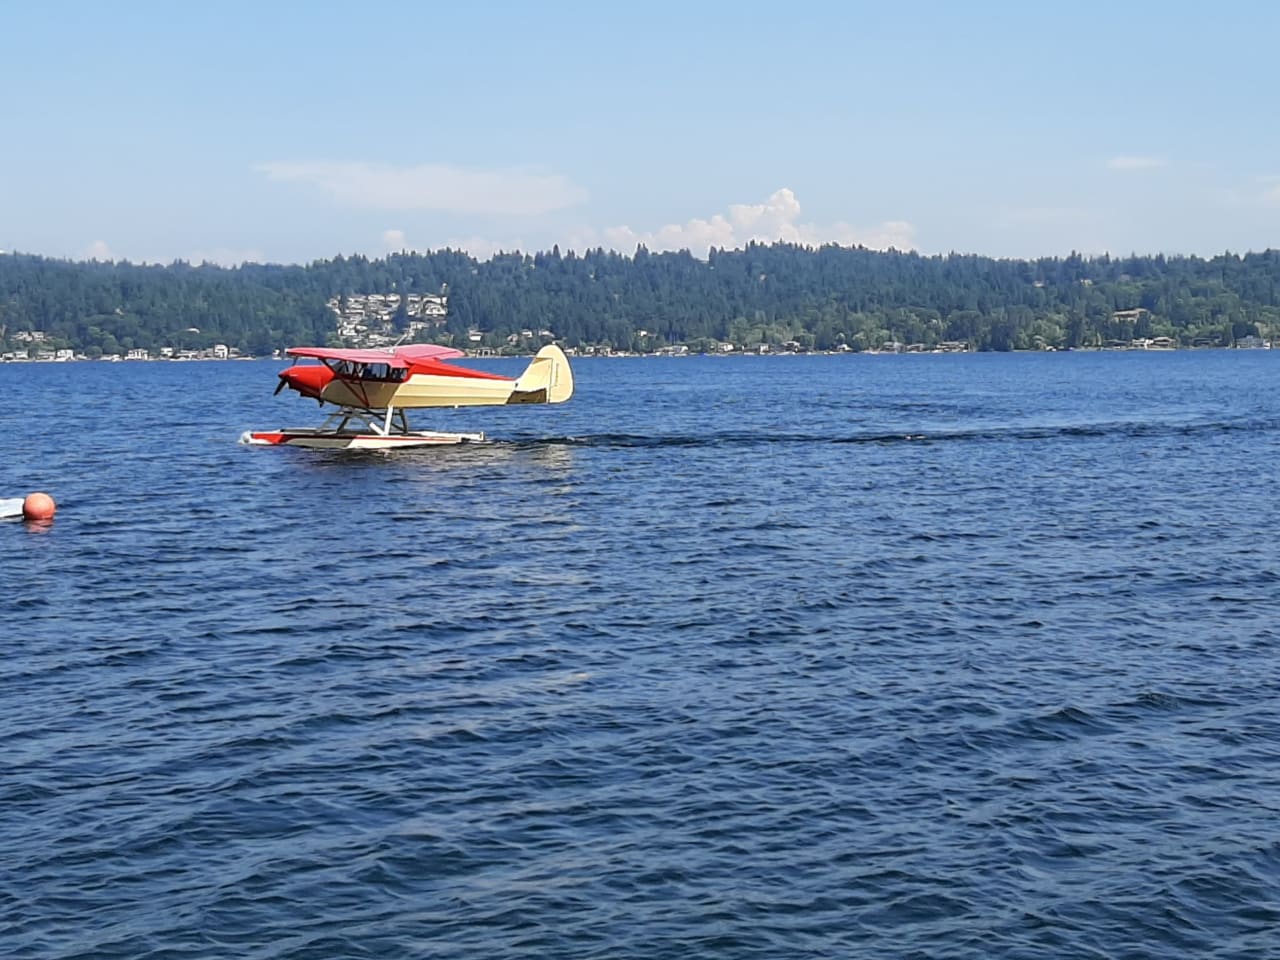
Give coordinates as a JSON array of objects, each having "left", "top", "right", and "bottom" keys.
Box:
[{"left": 0, "top": 351, "right": 1280, "bottom": 960}]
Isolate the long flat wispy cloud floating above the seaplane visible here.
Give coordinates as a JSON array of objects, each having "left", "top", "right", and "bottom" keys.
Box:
[{"left": 256, "top": 163, "right": 586, "bottom": 216}]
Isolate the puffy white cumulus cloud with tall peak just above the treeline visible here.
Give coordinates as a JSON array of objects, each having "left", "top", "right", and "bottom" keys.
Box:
[{"left": 573, "top": 187, "right": 915, "bottom": 255}]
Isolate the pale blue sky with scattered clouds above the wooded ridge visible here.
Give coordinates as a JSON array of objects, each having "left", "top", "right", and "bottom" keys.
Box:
[{"left": 0, "top": 0, "right": 1280, "bottom": 262}]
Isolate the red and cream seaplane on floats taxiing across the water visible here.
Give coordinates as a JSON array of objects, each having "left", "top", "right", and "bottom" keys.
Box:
[{"left": 241, "top": 343, "right": 573, "bottom": 451}]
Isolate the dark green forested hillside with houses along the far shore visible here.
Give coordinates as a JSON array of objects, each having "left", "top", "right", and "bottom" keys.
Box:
[{"left": 0, "top": 243, "right": 1280, "bottom": 356}]
